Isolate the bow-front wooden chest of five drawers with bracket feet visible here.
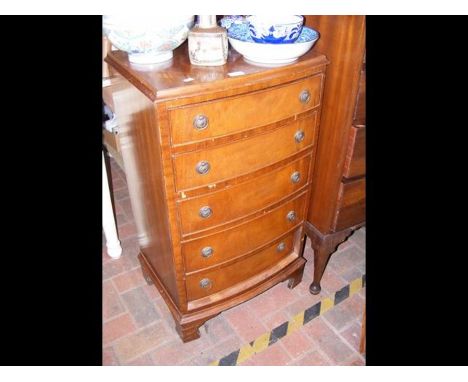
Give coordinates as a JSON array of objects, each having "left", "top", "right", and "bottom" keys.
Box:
[{"left": 106, "top": 44, "right": 328, "bottom": 342}]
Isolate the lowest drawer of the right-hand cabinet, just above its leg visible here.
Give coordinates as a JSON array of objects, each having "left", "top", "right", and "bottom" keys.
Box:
[{"left": 335, "top": 178, "right": 366, "bottom": 231}]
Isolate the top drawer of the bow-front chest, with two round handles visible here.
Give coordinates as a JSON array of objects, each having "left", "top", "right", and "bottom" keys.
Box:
[{"left": 169, "top": 74, "right": 322, "bottom": 145}]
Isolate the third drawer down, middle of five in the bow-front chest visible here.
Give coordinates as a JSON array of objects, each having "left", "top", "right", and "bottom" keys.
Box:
[{"left": 178, "top": 155, "right": 311, "bottom": 234}]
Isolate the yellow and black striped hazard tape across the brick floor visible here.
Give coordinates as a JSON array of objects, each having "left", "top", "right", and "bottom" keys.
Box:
[{"left": 210, "top": 274, "right": 366, "bottom": 366}]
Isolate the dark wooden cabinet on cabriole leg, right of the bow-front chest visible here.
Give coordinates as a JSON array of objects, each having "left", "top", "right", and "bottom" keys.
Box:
[{"left": 306, "top": 16, "right": 366, "bottom": 294}]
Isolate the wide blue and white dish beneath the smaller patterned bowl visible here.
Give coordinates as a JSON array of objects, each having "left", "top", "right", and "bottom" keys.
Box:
[{"left": 228, "top": 25, "right": 319, "bottom": 65}]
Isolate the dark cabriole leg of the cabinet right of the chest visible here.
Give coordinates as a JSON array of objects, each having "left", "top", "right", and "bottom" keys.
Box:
[{"left": 306, "top": 223, "right": 353, "bottom": 294}]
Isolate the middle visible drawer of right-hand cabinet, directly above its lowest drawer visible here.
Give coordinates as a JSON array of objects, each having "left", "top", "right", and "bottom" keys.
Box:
[{"left": 343, "top": 126, "right": 366, "bottom": 178}]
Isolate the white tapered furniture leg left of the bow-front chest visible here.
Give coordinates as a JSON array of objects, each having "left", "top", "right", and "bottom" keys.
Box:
[{"left": 102, "top": 153, "right": 122, "bottom": 259}]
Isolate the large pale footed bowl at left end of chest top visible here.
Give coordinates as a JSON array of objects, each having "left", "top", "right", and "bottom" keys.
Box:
[{"left": 102, "top": 14, "right": 195, "bottom": 64}]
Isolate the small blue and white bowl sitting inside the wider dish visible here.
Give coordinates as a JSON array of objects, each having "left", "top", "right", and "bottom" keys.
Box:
[{"left": 247, "top": 15, "right": 304, "bottom": 44}]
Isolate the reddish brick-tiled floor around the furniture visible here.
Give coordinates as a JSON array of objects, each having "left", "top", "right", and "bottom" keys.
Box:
[{"left": 102, "top": 156, "right": 365, "bottom": 365}]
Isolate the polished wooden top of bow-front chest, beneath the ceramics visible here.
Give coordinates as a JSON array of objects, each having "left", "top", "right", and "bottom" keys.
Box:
[{"left": 106, "top": 43, "right": 328, "bottom": 101}]
